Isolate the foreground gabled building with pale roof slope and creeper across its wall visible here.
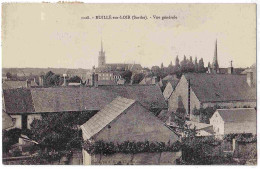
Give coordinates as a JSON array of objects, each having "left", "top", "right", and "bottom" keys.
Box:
[{"left": 81, "top": 97, "right": 179, "bottom": 164}]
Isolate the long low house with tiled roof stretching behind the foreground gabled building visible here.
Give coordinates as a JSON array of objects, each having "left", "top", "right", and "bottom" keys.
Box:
[{"left": 3, "top": 85, "right": 167, "bottom": 129}]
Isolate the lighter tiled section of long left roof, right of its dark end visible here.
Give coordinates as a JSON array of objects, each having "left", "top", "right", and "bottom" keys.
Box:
[{"left": 31, "top": 87, "right": 117, "bottom": 112}]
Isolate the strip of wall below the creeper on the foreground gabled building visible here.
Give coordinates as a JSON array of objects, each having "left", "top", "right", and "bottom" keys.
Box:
[{"left": 83, "top": 150, "right": 181, "bottom": 165}]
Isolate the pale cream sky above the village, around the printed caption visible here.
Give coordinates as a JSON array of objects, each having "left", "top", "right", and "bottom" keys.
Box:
[{"left": 2, "top": 3, "right": 256, "bottom": 69}]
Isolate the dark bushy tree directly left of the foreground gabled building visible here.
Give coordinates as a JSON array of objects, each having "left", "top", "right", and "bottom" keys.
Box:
[{"left": 31, "top": 112, "right": 95, "bottom": 152}]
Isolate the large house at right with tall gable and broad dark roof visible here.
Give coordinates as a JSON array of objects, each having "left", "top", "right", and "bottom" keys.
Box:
[{"left": 168, "top": 73, "right": 256, "bottom": 118}]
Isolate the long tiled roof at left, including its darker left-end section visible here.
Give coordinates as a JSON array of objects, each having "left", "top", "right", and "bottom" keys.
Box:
[{"left": 3, "top": 87, "right": 117, "bottom": 113}]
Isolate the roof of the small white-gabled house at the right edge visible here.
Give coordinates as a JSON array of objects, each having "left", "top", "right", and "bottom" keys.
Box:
[{"left": 217, "top": 108, "right": 256, "bottom": 122}]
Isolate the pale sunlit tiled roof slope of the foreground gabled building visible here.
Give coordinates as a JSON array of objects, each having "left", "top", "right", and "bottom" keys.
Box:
[{"left": 81, "top": 97, "right": 135, "bottom": 139}]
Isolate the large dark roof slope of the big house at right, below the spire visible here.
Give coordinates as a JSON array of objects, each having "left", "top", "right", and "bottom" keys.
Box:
[{"left": 184, "top": 73, "right": 256, "bottom": 102}]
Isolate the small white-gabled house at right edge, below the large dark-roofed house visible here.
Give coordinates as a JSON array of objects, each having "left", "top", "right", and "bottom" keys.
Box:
[{"left": 210, "top": 108, "right": 256, "bottom": 136}]
